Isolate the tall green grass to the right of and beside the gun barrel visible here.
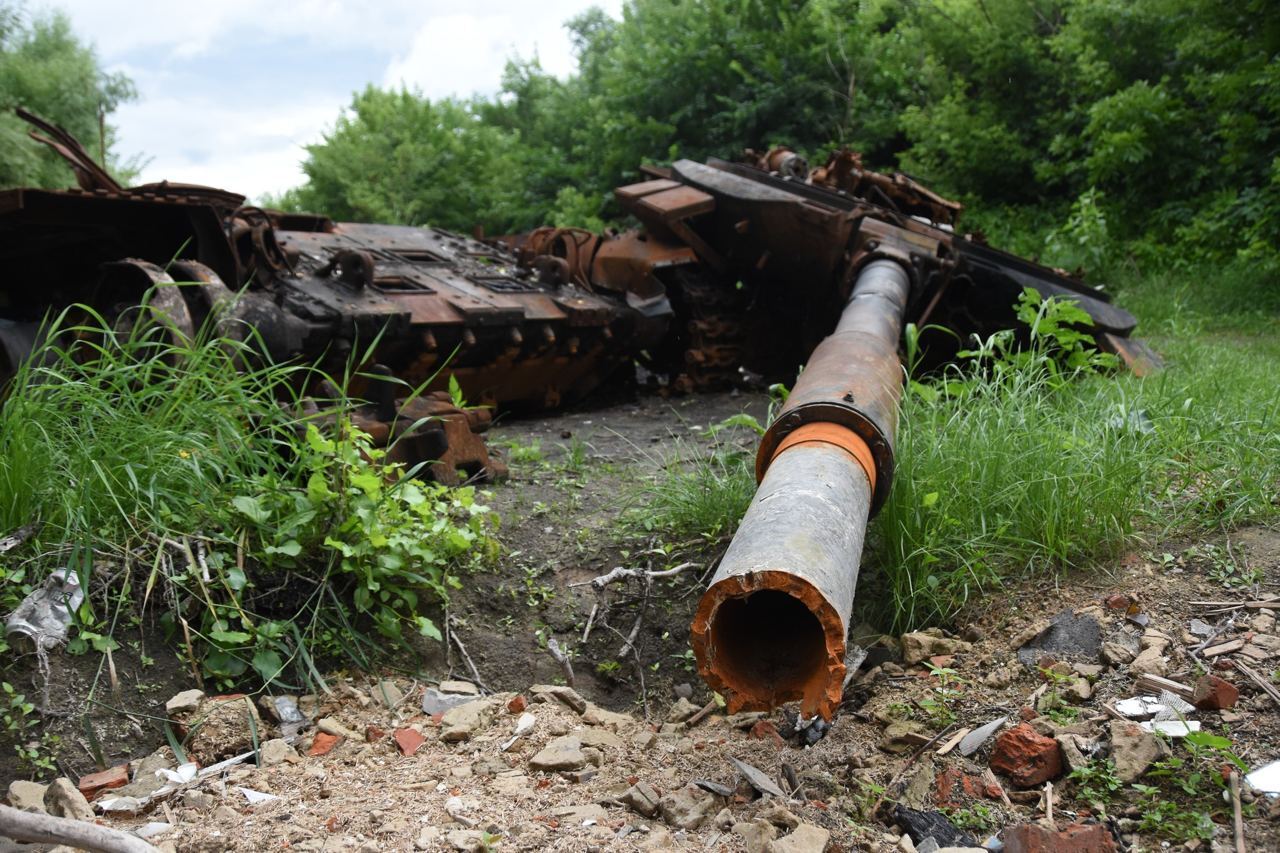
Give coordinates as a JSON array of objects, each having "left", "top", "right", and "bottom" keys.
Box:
[{"left": 648, "top": 262, "right": 1280, "bottom": 630}]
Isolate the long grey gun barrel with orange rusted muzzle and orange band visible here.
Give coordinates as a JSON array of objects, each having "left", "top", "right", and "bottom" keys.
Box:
[{"left": 691, "top": 260, "right": 910, "bottom": 720}]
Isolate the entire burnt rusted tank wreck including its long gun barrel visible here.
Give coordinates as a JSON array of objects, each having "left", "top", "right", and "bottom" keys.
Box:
[{"left": 0, "top": 108, "right": 1158, "bottom": 717}]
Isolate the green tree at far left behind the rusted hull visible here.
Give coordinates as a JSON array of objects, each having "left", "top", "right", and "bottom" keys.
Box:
[{"left": 0, "top": 3, "right": 134, "bottom": 187}]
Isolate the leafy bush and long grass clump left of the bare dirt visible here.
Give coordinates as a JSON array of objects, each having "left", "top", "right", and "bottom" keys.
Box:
[{"left": 0, "top": 290, "right": 490, "bottom": 683}]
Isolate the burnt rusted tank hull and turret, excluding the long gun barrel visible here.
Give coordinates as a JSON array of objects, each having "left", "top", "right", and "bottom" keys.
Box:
[{"left": 0, "top": 110, "right": 1156, "bottom": 482}]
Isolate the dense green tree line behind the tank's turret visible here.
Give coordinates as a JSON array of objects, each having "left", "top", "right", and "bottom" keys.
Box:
[{"left": 0, "top": 0, "right": 1280, "bottom": 268}]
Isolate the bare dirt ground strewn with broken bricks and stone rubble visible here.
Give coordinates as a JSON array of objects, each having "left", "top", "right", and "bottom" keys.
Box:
[{"left": 4, "top": 393, "right": 1280, "bottom": 853}]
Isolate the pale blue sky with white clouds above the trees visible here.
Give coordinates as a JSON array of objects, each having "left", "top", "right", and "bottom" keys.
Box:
[{"left": 36, "top": 0, "right": 622, "bottom": 199}]
